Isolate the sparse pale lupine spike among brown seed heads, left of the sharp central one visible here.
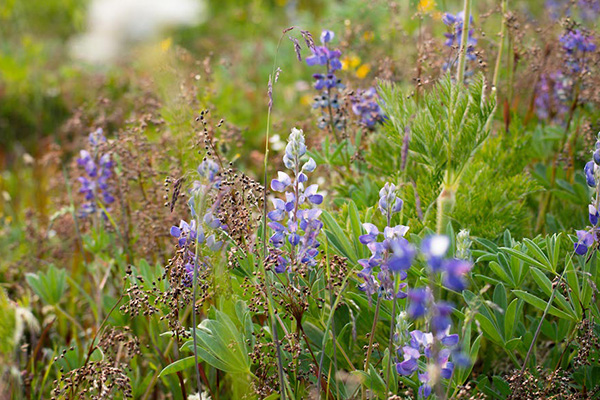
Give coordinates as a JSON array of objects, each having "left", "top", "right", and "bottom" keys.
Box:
[{"left": 170, "top": 159, "right": 226, "bottom": 286}]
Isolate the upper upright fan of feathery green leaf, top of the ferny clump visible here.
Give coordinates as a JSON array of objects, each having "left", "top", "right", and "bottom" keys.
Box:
[{"left": 380, "top": 75, "right": 495, "bottom": 183}]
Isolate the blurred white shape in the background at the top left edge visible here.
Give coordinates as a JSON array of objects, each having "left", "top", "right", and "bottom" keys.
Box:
[{"left": 71, "top": 0, "right": 205, "bottom": 64}]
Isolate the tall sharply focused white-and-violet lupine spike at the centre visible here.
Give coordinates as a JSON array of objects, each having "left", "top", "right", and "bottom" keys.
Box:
[{"left": 267, "top": 128, "right": 323, "bottom": 273}]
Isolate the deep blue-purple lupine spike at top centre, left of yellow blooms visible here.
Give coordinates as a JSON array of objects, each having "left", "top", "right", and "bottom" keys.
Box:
[{"left": 306, "top": 30, "right": 345, "bottom": 131}]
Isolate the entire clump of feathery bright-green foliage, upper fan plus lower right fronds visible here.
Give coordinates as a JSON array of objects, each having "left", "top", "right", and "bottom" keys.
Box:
[{"left": 376, "top": 76, "right": 540, "bottom": 237}]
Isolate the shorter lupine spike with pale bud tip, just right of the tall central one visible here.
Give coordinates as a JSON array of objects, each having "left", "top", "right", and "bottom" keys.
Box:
[{"left": 358, "top": 183, "right": 415, "bottom": 300}]
